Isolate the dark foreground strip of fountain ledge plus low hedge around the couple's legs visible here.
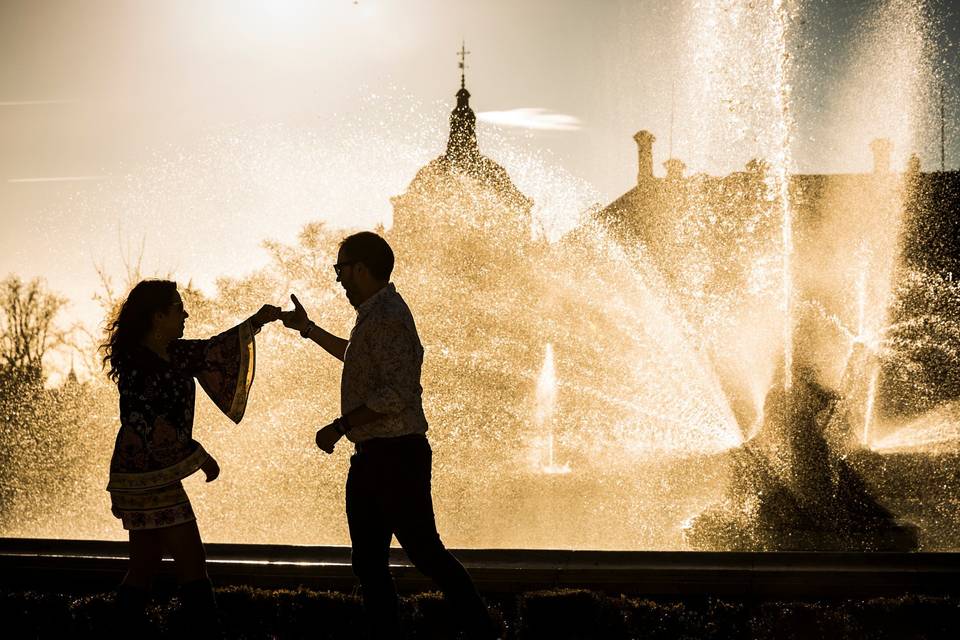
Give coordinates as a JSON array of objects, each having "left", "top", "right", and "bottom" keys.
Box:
[{"left": 0, "top": 538, "right": 960, "bottom": 640}]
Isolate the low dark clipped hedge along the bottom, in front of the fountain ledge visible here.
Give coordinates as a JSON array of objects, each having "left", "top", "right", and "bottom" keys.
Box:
[{"left": 0, "top": 586, "right": 960, "bottom": 640}]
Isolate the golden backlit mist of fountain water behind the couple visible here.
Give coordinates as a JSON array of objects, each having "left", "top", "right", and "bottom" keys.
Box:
[{"left": 2, "top": 0, "right": 960, "bottom": 549}]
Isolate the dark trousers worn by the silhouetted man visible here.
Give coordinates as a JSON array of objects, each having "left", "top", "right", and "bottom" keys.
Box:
[{"left": 347, "top": 435, "right": 495, "bottom": 638}]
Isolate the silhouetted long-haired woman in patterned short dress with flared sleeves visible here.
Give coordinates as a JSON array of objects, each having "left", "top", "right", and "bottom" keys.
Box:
[{"left": 102, "top": 280, "right": 280, "bottom": 636}]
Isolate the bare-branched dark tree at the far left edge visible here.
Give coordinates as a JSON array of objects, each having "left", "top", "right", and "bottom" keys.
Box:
[{"left": 0, "top": 276, "right": 67, "bottom": 381}]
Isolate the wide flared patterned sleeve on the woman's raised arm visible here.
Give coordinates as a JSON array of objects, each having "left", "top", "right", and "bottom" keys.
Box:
[{"left": 168, "top": 320, "right": 256, "bottom": 423}]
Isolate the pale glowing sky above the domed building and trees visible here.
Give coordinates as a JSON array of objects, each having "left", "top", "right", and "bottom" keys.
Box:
[{"left": 0, "top": 0, "right": 960, "bottom": 378}]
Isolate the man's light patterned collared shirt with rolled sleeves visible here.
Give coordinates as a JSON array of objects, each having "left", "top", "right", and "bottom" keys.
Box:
[{"left": 340, "top": 283, "right": 427, "bottom": 442}]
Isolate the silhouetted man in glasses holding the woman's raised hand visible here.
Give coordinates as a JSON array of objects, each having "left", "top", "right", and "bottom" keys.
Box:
[{"left": 283, "top": 232, "right": 496, "bottom": 638}]
